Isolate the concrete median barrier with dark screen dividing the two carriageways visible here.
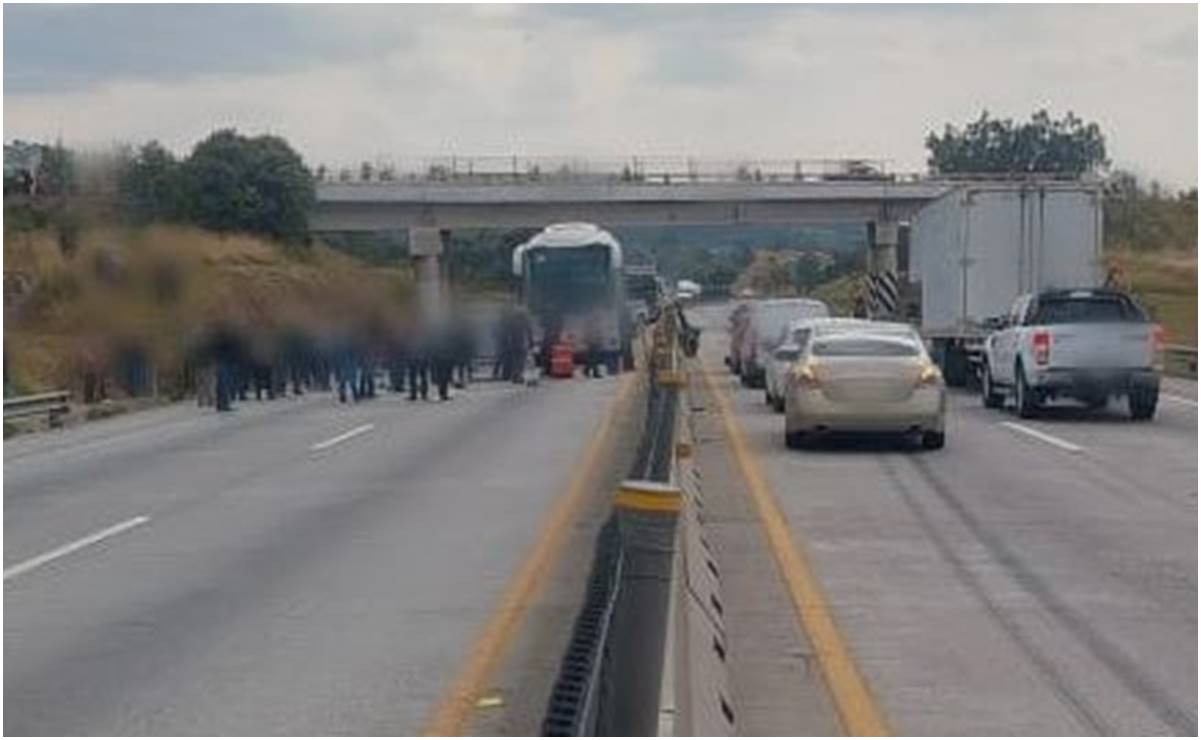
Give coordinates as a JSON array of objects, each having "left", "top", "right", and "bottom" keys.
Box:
[{"left": 543, "top": 306, "right": 736, "bottom": 735}]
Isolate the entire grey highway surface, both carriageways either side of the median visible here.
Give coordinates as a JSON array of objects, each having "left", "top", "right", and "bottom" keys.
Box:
[{"left": 4, "top": 305, "right": 1197, "bottom": 735}]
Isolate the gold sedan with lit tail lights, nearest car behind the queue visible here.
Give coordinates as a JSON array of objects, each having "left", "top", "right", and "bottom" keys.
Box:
[{"left": 784, "top": 326, "right": 946, "bottom": 449}]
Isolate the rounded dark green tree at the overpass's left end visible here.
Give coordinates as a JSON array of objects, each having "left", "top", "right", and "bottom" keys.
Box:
[{"left": 183, "top": 129, "right": 316, "bottom": 241}]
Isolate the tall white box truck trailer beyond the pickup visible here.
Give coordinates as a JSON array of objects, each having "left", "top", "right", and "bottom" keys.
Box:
[{"left": 908, "top": 181, "right": 1103, "bottom": 386}]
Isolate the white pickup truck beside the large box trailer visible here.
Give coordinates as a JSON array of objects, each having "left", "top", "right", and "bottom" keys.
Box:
[{"left": 980, "top": 288, "right": 1164, "bottom": 420}]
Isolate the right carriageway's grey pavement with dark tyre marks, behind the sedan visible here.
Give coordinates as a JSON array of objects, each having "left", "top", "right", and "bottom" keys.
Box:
[{"left": 692, "top": 306, "right": 1197, "bottom": 735}]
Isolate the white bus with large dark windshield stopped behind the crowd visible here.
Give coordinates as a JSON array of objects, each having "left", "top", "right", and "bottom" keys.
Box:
[{"left": 512, "top": 222, "right": 634, "bottom": 374}]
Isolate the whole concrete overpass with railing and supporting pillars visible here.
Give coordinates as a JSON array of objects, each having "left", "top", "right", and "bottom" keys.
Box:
[{"left": 310, "top": 157, "right": 1090, "bottom": 315}]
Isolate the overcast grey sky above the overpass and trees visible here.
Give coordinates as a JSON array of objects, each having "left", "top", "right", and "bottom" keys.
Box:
[{"left": 4, "top": 5, "right": 1197, "bottom": 186}]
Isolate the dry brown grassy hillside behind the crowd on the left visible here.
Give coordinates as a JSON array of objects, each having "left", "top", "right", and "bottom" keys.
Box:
[{"left": 4, "top": 227, "right": 411, "bottom": 393}]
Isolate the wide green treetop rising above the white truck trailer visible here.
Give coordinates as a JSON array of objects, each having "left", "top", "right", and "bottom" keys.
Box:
[{"left": 926, "top": 111, "right": 1109, "bottom": 175}]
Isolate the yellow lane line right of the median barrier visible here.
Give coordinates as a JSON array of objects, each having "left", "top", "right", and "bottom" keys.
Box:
[{"left": 703, "top": 369, "right": 892, "bottom": 736}]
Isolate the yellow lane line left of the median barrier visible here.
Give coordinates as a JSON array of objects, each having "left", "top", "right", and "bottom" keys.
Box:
[{"left": 423, "top": 372, "right": 638, "bottom": 735}]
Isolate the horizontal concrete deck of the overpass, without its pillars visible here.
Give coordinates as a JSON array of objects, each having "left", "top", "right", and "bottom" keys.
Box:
[{"left": 311, "top": 179, "right": 955, "bottom": 232}]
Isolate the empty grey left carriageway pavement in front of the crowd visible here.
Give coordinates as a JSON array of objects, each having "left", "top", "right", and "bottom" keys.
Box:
[{"left": 5, "top": 378, "right": 619, "bottom": 735}]
